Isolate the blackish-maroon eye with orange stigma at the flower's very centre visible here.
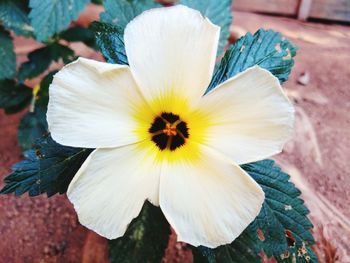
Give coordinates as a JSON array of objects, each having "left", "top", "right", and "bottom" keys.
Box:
[{"left": 148, "top": 112, "right": 189, "bottom": 151}]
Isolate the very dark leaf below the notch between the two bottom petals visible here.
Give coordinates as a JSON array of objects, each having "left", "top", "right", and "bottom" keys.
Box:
[{"left": 109, "top": 202, "right": 170, "bottom": 263}]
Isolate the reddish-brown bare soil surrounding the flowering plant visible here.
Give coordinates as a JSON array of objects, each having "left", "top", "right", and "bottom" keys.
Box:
[{"left": 0, "top": 6, "right": 350, "bottom": 263}]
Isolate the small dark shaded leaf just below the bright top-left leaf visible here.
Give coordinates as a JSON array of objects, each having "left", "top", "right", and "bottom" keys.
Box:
[{"left": 59, "top": 26, "right": 95, "bottom": 48}]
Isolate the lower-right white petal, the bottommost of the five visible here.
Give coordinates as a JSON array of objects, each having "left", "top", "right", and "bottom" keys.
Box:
[{"left": 159, "top": 146, "right": 264, "bottom": 248}]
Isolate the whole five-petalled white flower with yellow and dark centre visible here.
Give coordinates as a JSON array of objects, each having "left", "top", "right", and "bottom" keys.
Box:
[{"left": 47, "top": 5, "right": 294, "bottom": 247}]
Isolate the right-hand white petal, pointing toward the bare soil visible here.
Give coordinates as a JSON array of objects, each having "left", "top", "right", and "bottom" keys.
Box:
[{"left": 200, "top": 66, "right": 294, "bottom": 164}]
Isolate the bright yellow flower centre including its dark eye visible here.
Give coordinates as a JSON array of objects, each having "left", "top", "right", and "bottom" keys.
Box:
[{"left": 131, "top": 93, "right": 213, "bottom": 162}]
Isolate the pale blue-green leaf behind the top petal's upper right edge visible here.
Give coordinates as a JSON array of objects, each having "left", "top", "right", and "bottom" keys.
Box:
[{"left": 179, "top": 0, "right": 232, "bottom": 55}]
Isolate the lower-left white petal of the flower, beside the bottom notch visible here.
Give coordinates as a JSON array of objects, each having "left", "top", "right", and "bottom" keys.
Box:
[{"left": 67, "top": 144, "right": 160, "bottom": 239}]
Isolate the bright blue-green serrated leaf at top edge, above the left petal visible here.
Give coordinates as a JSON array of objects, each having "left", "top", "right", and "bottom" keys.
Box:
[{"left": 29, "top": 0, "right": 90, "bottom": 41}]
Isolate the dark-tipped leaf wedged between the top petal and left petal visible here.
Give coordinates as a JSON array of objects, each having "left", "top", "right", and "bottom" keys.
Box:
[{"left": 90, "top": 22, "right": 129, "bottom": 65}]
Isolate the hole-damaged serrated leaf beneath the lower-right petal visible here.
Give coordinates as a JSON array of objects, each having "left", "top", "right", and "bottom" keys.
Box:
[{"left": 242, "top": 160, "right": 314, "bottom": 262}]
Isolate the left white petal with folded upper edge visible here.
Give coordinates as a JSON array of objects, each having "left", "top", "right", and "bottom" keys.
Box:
[{"left": 47, "top": 58, "right": 148, "bottom": 148}]
